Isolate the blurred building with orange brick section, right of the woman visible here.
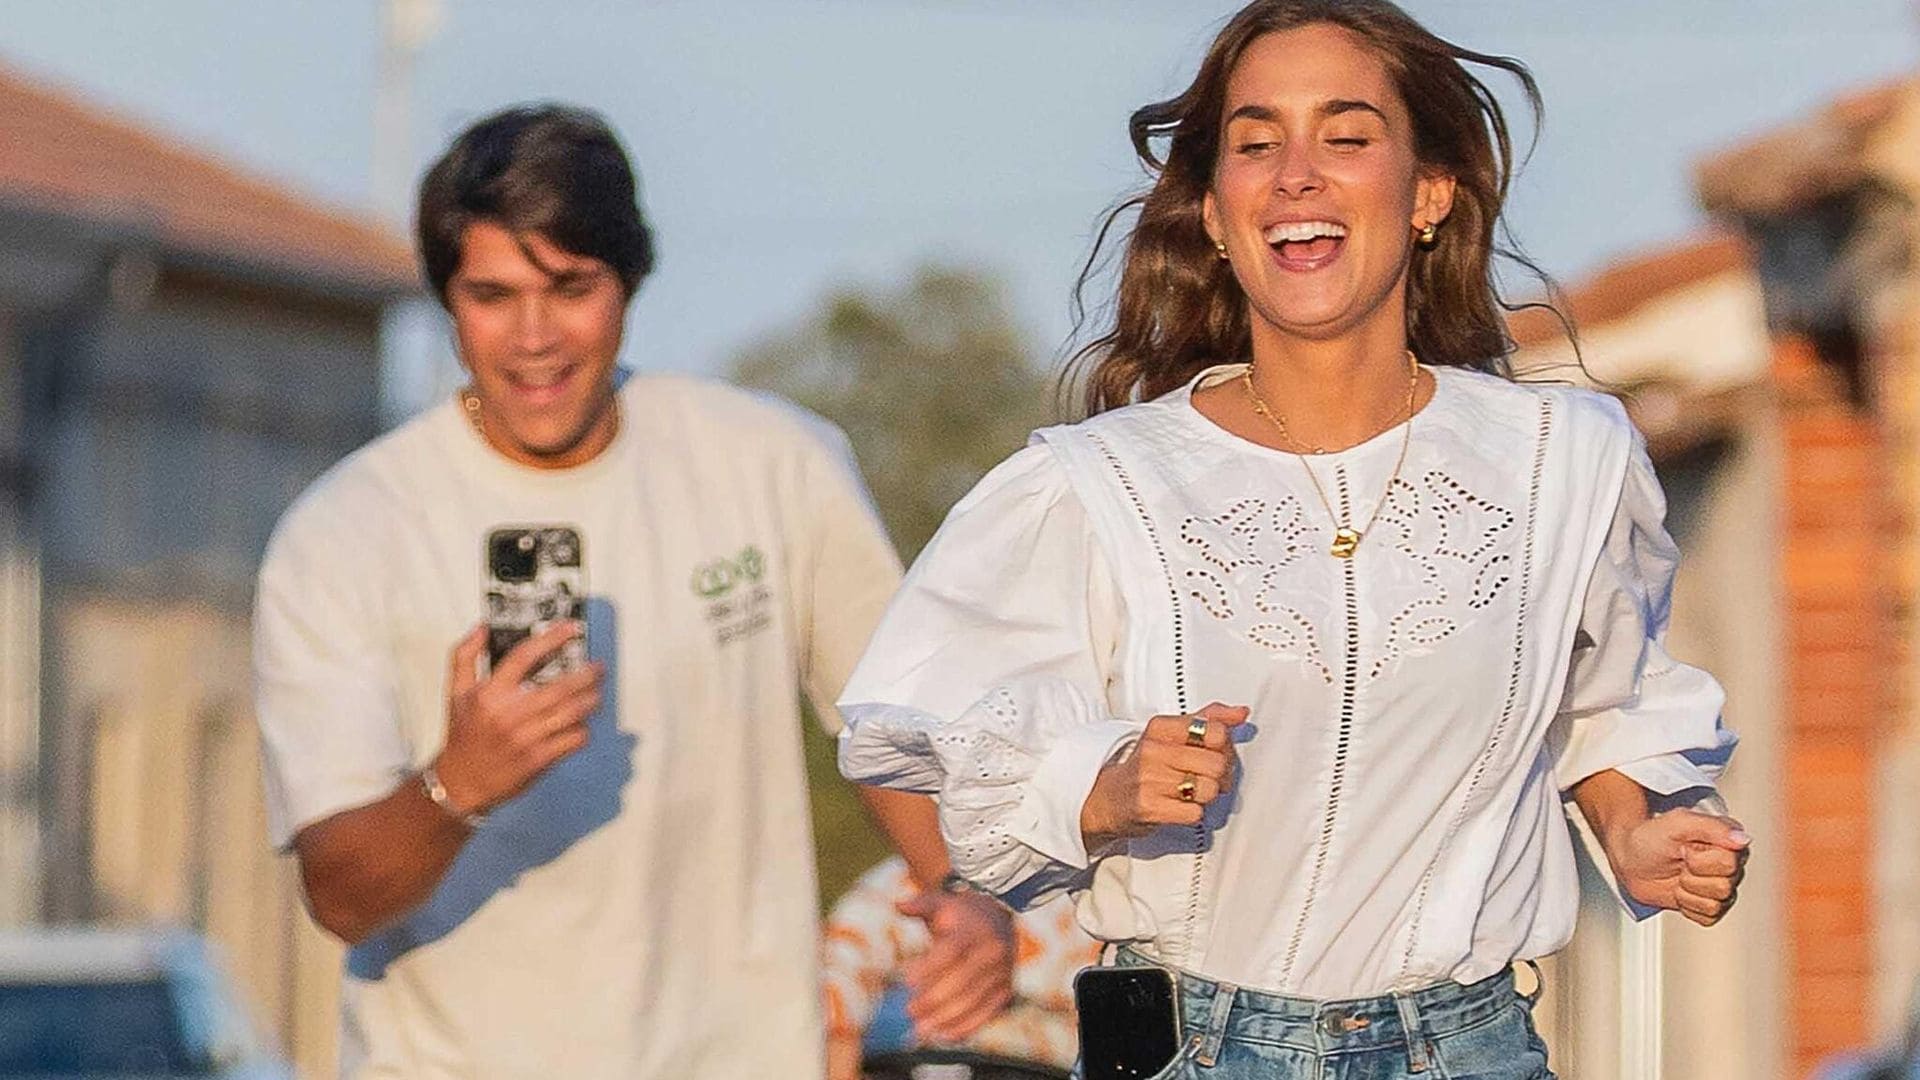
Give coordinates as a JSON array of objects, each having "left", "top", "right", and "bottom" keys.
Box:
[{"left": 1515, "top": 83, "right": 1920, "bottom": 1080}]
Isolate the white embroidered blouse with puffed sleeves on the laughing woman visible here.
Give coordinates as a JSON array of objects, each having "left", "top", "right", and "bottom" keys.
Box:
[{"left": 839, "top": 365, "right": 1734, "bottom": 997}]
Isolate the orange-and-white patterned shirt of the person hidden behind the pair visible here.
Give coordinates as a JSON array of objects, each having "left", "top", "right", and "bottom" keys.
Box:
[{"left": 820, "top": 857, "right": 1100, "bottom": 1080}]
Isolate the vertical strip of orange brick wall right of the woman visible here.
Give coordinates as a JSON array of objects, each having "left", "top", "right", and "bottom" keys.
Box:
[{"left": 1759, "top": 340, "right": 1897, "bottom": 1076}]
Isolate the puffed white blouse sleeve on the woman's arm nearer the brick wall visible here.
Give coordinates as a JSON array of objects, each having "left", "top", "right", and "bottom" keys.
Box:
[{"left": 1548, "top": 438, "right": 1736, "bottom": 796}]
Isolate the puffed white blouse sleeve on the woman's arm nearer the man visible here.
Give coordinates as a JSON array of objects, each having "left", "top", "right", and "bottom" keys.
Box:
[{"left": 839, "top": 446, "right": 1142, "bottom": 907}]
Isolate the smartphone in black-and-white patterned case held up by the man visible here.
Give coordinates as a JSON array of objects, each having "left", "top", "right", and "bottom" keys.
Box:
[{"left": 486, "top": 525, "right": 588, "bottom": 682}]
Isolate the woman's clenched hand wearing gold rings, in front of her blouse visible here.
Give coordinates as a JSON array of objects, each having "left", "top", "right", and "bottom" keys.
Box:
[{"left": 1081, "top": 701, "right": 1248, "bottom": 851}]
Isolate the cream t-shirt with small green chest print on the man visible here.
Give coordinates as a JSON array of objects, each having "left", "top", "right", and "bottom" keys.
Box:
[{"left": 255, "top": 377, "right": 899, "bottom": 1080}]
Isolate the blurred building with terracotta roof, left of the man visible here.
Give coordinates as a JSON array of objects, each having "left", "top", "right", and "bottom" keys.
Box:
[{"left": 0, "top": 62, "right": 417, "bottom": 1067}]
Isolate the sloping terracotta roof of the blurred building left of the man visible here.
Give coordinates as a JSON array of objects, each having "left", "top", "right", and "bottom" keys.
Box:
[{"left": 0, "top": 58, "right": 419, "bottom": 292}]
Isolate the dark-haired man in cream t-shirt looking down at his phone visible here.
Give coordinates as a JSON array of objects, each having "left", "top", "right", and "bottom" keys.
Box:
[{"left": 255, "top": 108, "right": 1010, "bottom": 1080}]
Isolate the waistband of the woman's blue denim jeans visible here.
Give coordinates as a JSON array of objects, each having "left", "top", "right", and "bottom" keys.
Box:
[{"left": 1114, "top": 945, "right": 1530, "bottom": 1063}]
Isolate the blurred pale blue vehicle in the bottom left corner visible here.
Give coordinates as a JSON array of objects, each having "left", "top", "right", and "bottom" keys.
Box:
[{"left": 0, "top": 926, "right": 294, "bottom": 1080}]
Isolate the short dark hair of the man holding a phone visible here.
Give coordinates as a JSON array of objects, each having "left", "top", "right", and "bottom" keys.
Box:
[{"left": 415, "top": 106, "right": 653, "bottom": 304}]
